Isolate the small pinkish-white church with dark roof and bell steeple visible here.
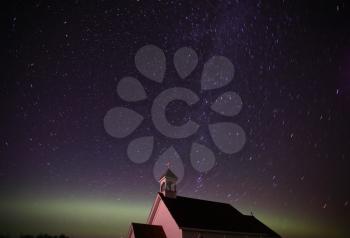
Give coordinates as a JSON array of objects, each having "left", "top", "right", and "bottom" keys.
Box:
[{"left": 128, "top": 169, "right": 280, "bottom": 238}]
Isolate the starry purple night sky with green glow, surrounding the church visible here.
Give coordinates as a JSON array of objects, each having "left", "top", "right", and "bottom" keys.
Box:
[{"left": 0, "top": 0, "right": 350, "bottom": 238}]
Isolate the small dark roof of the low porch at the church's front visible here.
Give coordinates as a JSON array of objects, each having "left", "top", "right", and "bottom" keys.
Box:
[{"left": 131, "top": 223, "right": 166, "bottom": 238}]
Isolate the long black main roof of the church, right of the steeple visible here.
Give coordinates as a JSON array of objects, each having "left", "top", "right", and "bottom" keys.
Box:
[{"left": 159, "top": 193, "right": 280, "bottom": 237}]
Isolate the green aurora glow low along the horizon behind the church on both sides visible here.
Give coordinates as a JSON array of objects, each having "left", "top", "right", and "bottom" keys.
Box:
[{"left": 0, "top": 195, "right": 343, "bottom": 237}]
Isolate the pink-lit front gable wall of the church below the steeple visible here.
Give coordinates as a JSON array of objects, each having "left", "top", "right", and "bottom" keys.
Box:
[{"left": 151, "top": 201, "right": 182, "bottom": 238}]
